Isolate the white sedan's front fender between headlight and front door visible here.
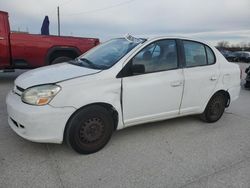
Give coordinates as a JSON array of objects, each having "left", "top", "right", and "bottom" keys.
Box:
[{"left": 50, "top": 73, "right": 124, "bottom": 129}]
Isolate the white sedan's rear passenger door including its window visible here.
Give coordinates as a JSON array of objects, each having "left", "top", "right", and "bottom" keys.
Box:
[{"left": 180, "top": 40, "right": 219, "bottom": 114}]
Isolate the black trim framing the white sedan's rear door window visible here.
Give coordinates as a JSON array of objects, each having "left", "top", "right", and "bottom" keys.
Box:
[{"left": 181, "top": 39, "right": 217, "bottom": 68}]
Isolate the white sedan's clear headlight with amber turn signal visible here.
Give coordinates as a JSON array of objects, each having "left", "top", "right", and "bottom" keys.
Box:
[{"left": 22, "top": 84, "right": 61, "bottom": 106}]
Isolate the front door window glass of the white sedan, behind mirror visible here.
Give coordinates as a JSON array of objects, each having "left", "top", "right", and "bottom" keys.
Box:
[{"left": 131, "top": 40, "right": 178, "bottom": 73}]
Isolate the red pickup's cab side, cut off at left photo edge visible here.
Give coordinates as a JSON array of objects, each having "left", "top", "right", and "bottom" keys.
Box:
[{"left": 0, "top": 12, "right": 10, "bottom": 69}]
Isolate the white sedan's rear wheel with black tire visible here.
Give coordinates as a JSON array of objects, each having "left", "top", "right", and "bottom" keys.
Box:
[{"left": 200, "top": 93, "right": 227, "bottom": 123}]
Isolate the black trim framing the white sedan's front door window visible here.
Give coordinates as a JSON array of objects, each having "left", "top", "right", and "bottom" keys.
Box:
[{"left": 116, "top": 38, "right": 183, "bottom": 78}]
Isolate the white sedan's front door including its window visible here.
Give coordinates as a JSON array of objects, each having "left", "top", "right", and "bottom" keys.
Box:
[{"left": 122, "top": 40, "right": 184, "bottom": 126}]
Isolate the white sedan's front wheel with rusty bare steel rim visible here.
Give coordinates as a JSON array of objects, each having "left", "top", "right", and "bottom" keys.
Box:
[{"left": 65, "top": 105, "right": 114, "bottom": 154}]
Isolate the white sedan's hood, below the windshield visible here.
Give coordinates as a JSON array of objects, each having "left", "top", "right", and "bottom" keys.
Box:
[{"left": 15, "top": 63, "right": 101, "bottom": 89}]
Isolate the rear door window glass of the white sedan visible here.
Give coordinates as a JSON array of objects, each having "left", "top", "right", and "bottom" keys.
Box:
[{"left": 183, "top": 41, "right": 215, "bottom": 67}]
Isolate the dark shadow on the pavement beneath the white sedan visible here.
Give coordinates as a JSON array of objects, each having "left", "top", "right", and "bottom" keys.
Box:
[{"left": 53, "top": 115, "right": 213, "bottom": 157}]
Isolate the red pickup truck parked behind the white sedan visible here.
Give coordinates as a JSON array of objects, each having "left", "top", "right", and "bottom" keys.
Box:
[{"left": 0, "top": 11, "right": 99, "bottom": 71}]
